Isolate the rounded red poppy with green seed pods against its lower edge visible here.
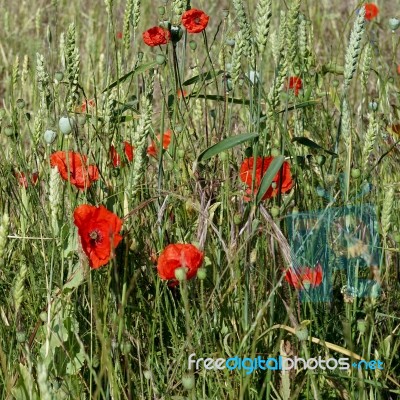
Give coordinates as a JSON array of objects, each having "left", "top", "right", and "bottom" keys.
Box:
[{"left": 157, "top": 244, "right": 204, "bottom": 285}]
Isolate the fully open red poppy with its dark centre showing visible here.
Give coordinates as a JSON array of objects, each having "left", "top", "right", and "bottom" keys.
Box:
[{"left": 74, "top": 204, "right": 122, "bottom": 269}]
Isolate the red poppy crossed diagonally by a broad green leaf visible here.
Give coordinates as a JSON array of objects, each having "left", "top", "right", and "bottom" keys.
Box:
[{"left": 239, "top": 157, "right": 293, "bottom": 200}]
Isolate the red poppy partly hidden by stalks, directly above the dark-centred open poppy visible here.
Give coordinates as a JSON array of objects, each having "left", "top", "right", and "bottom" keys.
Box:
[{"left": 50, "top": 151, "right": 99, "bottom": 190}]
